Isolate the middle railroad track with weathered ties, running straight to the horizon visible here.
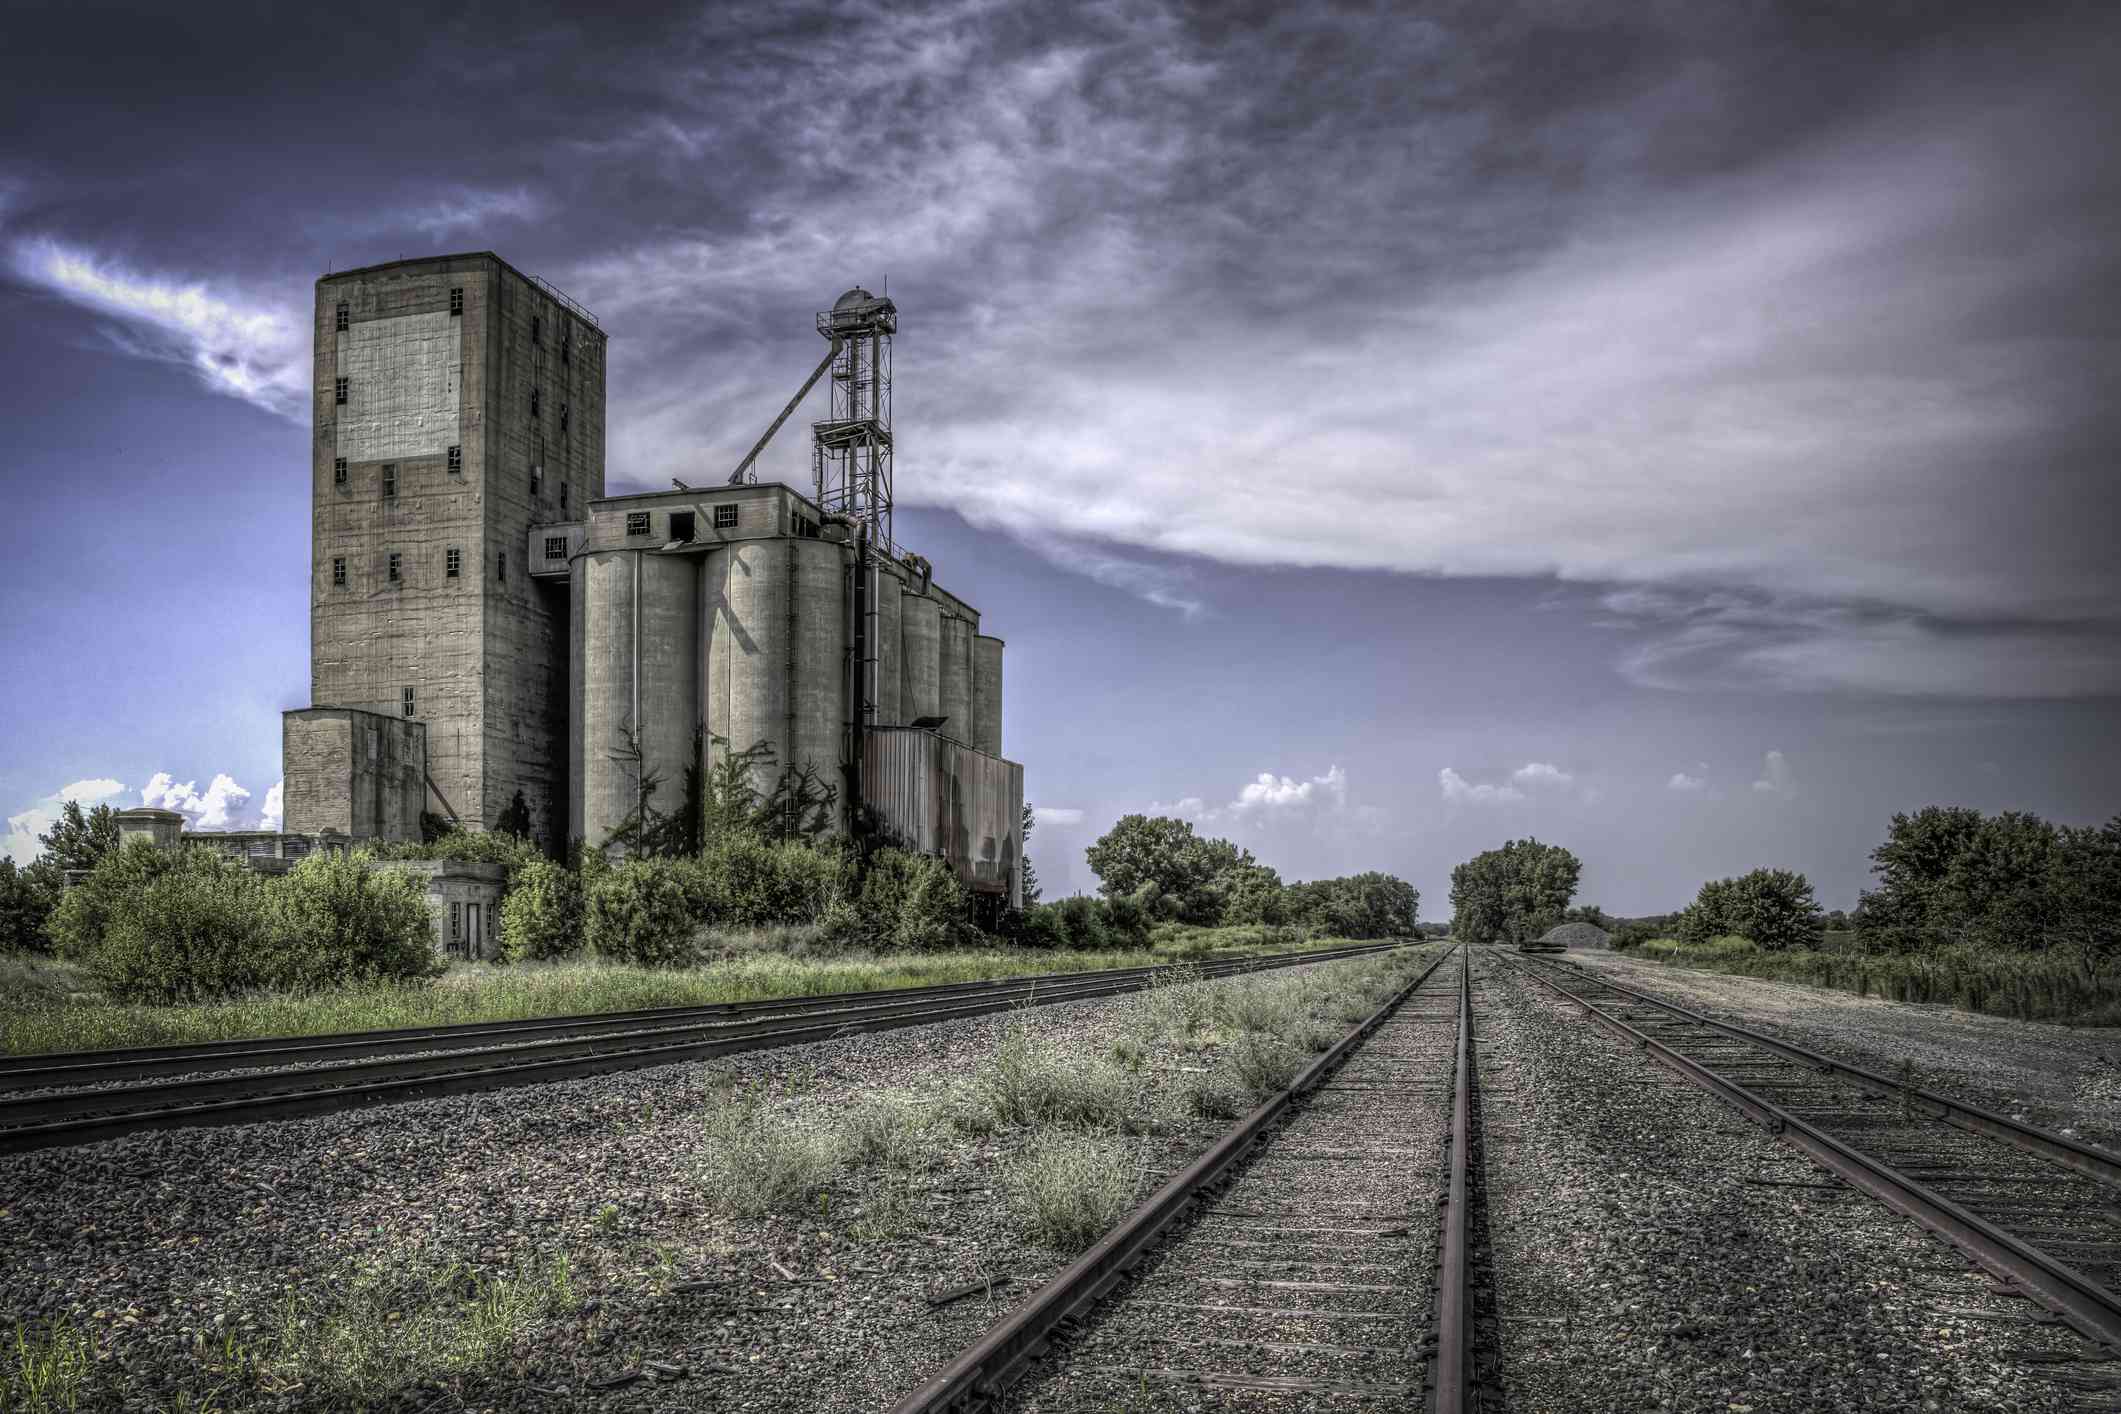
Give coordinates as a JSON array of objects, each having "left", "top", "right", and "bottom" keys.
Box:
[{"left": 893, "top": 950, "right": 1493, "bottom": 1414}]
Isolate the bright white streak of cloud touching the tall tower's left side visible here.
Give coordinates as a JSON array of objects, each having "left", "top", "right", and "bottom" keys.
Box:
[{"left": 13, "top": 237, "right": 312, "bottom": 422}]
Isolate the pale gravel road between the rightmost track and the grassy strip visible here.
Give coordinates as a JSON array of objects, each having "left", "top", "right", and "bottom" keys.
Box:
[{"left": 1572, "top": 954, "right": 2121, "bottom": 1149}]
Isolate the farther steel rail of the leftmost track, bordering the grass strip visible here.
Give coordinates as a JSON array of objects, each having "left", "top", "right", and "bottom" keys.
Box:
[{"left": 0, "top": 943, "right": 1404, "bottom": 1090}]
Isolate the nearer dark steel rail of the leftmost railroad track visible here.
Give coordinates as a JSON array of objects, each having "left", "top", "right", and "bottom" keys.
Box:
[{"left": 0, "top": 954, "right": 1425, "bottom": 1153}]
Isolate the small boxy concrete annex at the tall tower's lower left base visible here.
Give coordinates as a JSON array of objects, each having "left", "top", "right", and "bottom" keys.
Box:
[{"left": 280, "top": 708, "right": 426, "bottom": 839}]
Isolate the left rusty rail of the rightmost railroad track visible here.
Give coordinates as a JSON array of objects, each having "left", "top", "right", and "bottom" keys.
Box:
[{"left": 1508, "top": 949, "right": 2121, "bottom": 1350}]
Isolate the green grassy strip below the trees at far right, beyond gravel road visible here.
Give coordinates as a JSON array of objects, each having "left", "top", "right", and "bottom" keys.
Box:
[{"left": 1629, "top": 937, "right": 2121, "bottom": 1026}]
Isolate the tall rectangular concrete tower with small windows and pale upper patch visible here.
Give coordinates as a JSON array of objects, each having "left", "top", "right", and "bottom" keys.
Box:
[{"left": 286, "top": 252, "right": 604, "bottom": 844}]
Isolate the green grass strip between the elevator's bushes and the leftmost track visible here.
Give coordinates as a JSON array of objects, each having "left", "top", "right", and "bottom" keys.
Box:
[{"left": 0, "top": 929, "right": 1391, "bottom": 1056}]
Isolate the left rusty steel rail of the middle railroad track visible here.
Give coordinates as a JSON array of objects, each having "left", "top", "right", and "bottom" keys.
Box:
[{"left": 891, "top": 948, "right": 1455, "bottom": 1414}]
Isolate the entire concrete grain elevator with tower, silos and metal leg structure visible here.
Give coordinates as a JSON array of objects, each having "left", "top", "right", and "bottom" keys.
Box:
[{"left": 284, "top": 252, "right": 1022, "bottom": 903}]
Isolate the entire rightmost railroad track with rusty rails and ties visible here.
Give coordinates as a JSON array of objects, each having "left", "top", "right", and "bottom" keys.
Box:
[{"left": 1497, "top": 950, "right": 2121, "bottom": 1359}]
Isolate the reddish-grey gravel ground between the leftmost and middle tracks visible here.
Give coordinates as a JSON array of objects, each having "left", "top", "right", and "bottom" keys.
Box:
[{"left": 0, "top": 949, "right": 1425, "bottom": 1412}]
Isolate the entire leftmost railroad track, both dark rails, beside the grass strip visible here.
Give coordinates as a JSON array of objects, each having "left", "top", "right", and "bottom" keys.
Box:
[{"left": 0, "top": 943, "right": 1404, "bottom": 1153}]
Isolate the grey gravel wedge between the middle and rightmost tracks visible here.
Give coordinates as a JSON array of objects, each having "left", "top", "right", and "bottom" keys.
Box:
[{"left": 1476, "top": 958, "right": 2074, "bottom": 1414}]
